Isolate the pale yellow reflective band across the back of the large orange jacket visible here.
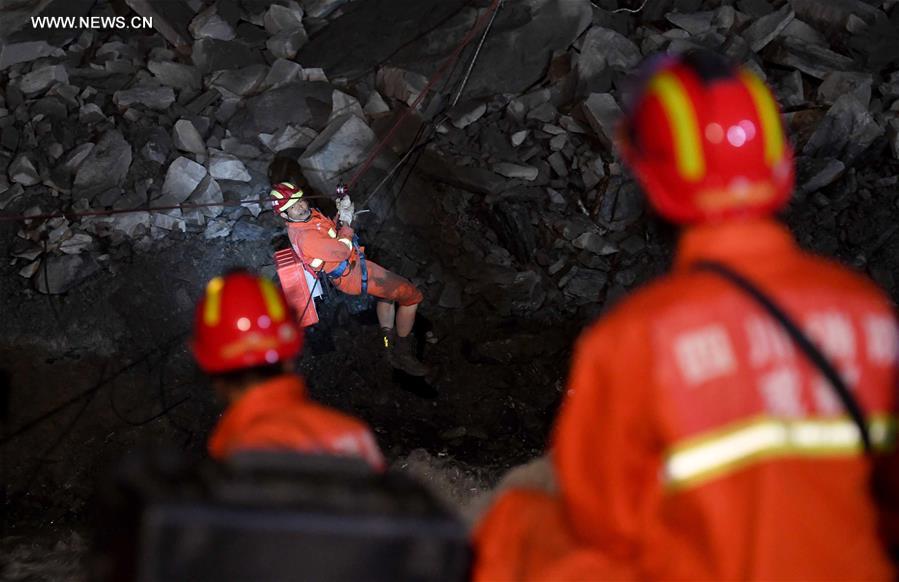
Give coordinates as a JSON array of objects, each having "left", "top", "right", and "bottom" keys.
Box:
[{"left": 664, "top": 415, "right": 896, "bottom": 491}]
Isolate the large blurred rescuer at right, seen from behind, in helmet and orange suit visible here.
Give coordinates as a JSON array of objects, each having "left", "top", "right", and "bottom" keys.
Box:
[{"left": 475, "top": 53, "right": 899, "bottom": 580}]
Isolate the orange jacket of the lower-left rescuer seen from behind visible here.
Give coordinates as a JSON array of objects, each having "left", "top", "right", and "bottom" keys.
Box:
[{"left": 209, "top": 374, "right": 384, "bottom": 470}]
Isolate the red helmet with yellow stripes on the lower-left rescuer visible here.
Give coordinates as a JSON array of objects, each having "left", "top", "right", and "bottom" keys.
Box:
[{"left": 191, "top": 273, "right": 303, "bottom": 373}]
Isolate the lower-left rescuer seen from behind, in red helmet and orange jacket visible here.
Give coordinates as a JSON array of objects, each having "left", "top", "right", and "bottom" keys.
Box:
[{"left": 192, "top": 272, "right": 384, "bottom": 470}]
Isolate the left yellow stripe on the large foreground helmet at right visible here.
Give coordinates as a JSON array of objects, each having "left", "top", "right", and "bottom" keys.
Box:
[{"left": 649, "top": 72, "right": 705, "bottom": 181}]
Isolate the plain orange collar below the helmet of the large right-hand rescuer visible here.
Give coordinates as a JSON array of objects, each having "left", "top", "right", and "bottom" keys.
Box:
[{"left": 674, "top": 219, "right": 796, "bottom": 271}]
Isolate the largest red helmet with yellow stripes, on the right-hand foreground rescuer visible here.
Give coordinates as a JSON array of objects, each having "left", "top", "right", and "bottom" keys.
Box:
[{"left": 617, "top": 52, "right": 794, "bottom": 223}]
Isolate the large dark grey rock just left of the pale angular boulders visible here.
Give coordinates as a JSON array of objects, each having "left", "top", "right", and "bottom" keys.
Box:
[{"left": 73, "top": 129, "right": 131, "bottom": 199}]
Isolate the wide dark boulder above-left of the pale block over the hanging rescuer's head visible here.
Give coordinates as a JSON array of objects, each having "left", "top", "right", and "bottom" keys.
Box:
[{"left": 231, "top": 81, "right": 333, "bottom": 138}]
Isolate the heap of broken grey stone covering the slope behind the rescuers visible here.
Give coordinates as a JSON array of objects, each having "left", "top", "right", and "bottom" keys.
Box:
[{"left": 0, "top": 0, "right": 899, "bottom": 311}]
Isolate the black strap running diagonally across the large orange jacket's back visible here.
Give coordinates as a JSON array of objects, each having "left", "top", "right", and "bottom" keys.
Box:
[{"left": 693, "top": 260, "right": 871, "bottom": 453}]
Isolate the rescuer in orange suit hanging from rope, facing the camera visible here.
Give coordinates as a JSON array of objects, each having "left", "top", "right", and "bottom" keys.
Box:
[{"left": 271, "top": 182, "right": 429, "bottom": 376}]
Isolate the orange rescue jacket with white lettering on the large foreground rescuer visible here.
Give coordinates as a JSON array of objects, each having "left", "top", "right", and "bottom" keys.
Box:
[{"left": 553, "top": 220, "right": 899, "bottom": 580}]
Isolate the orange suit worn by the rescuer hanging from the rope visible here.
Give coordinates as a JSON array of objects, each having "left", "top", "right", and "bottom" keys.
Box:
[{"left": 287, "top": 209, "right": 422, "bottom": 305}]
